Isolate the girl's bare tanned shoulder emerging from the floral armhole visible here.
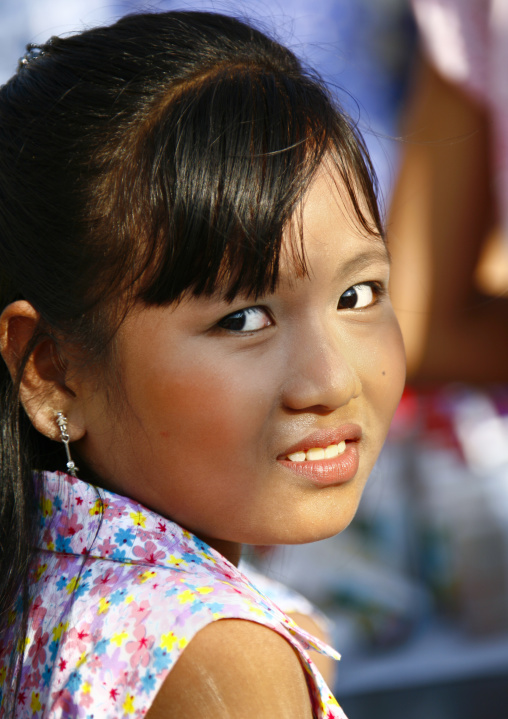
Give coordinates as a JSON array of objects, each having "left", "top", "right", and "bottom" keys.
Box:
[{"left": 145, "top": 619, "right": 312, "bottom": 719}]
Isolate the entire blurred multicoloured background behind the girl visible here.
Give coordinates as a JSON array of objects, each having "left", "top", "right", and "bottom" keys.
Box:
[{"left": 0, "top": 0, "right": 508, "bottom": 719}]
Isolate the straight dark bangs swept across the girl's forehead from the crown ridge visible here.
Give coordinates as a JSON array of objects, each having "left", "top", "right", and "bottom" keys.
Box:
[{"left": 123, "top": 65, "right": 377, "bottom": 305}]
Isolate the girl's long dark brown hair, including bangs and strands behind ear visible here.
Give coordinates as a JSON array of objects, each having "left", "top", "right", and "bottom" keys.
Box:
[{"left": 0, "top": 12, "right": 382, "bottom": 712}]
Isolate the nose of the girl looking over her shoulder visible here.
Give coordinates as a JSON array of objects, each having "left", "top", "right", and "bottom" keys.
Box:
[{"left": 283, "top": 325, "right": 362, "bottom": 413}]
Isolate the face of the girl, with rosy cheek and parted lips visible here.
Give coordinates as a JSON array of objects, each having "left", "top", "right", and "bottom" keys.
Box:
[{"left": 74, "top": 169, "right": 404, "bottom": 557}]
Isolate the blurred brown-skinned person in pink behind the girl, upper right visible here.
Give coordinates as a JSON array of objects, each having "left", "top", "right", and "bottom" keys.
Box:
[{"left": 388, "top": 0, "right": 508, "bottom": 382}]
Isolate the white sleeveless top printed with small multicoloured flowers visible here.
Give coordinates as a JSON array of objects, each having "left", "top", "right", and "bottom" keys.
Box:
[{"left": 0, "top": 472, "right": 345, "bottom": 719}]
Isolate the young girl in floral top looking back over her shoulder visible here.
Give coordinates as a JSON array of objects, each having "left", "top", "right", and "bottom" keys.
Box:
[{"left": 0, "top": 12, "right": 404, "bottom": 719}]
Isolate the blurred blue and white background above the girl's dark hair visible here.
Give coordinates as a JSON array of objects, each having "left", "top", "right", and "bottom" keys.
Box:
[{"left": 0, "top": 0, "right": 414, "bottom": 202}]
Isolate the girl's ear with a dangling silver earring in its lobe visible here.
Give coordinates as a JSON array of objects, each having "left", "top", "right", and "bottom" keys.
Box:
[{"left": 0, "top": 300, "right": 84, "bottom": 442}]
